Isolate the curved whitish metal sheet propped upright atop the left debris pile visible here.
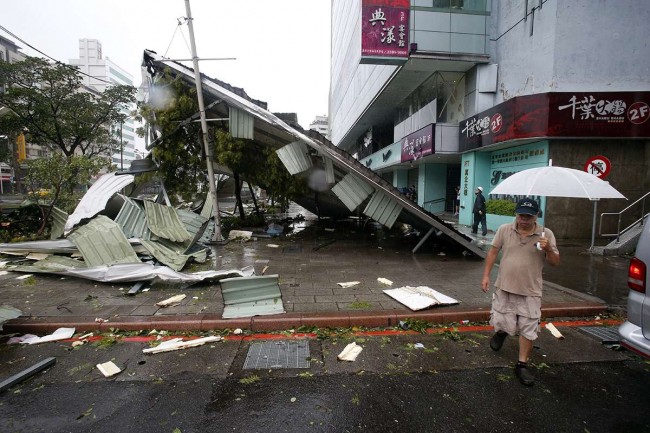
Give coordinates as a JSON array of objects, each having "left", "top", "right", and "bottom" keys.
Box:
[{"left": 65, "top": 173, "right": 134, "bottom": 232}]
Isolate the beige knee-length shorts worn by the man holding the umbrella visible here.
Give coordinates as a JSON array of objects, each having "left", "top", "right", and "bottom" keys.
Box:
[{"left": 490, "top": 289, "right": 542, "bottom": 340}]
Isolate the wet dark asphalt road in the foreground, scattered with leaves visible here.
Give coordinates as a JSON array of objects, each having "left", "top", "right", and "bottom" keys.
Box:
[{"left": 0, "top": 327, "right": 650, "bottom": 433}]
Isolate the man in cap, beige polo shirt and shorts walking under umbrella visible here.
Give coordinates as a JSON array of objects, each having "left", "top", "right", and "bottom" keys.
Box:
[{"left": 481, "top": 198, "right": 560, "bottom": 386}]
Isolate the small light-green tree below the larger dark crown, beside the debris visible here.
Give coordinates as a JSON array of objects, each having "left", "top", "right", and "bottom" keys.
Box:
[{"left": 26, "top": 152, "right": 110, "bottom": 235}]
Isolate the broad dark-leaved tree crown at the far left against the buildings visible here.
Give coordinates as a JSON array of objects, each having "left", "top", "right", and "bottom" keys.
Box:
[{"left": 0, "top": 57, "right": 135, "bottom": 157}]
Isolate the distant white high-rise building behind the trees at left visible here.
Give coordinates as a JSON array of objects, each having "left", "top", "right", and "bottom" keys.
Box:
[{"left": 69, "top": 39, "right": 137, "bottom": 170}]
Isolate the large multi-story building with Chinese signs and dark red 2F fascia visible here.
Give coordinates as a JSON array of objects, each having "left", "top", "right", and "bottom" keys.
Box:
[{"left": 329, "top": 0, "right": 650, "bottom": 238}]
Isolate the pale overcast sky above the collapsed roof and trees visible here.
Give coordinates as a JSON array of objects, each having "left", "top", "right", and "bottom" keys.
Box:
[{"left": 0, "top": 0, "right": 330, "bottom": 128}]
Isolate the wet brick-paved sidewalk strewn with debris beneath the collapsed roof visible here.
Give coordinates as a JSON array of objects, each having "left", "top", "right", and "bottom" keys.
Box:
[{"left": 0, "top": 223, "right": 607, "bottom": 333}]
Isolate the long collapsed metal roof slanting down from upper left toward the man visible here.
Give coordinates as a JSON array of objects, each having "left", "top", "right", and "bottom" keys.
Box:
[{"left": 143, "top": 50, "right": 485, "bottom": 258}]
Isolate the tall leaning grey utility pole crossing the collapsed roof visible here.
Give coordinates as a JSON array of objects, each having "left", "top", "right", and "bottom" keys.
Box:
[{"left": 185, "top": 0, "right": 223, "bottom": 242}]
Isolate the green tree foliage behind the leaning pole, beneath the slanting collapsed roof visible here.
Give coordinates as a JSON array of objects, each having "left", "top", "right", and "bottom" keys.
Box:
[{"left": 140, "top": 71, "right": 307, "bottom": 213}]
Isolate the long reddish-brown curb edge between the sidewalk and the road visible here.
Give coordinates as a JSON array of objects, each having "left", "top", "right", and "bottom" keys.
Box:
[{"left": 3, "top": 302, "right": 607, "bottom": 334}]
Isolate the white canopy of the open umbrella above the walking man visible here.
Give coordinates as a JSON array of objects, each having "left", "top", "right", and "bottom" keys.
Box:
[{"left": 490, "top": 166, "right": 625, "bottom": 200}]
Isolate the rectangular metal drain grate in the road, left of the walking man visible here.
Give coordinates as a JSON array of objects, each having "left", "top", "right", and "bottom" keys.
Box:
[{"left": 244, "top": 340, "right": 310, "bottom": 370}]
